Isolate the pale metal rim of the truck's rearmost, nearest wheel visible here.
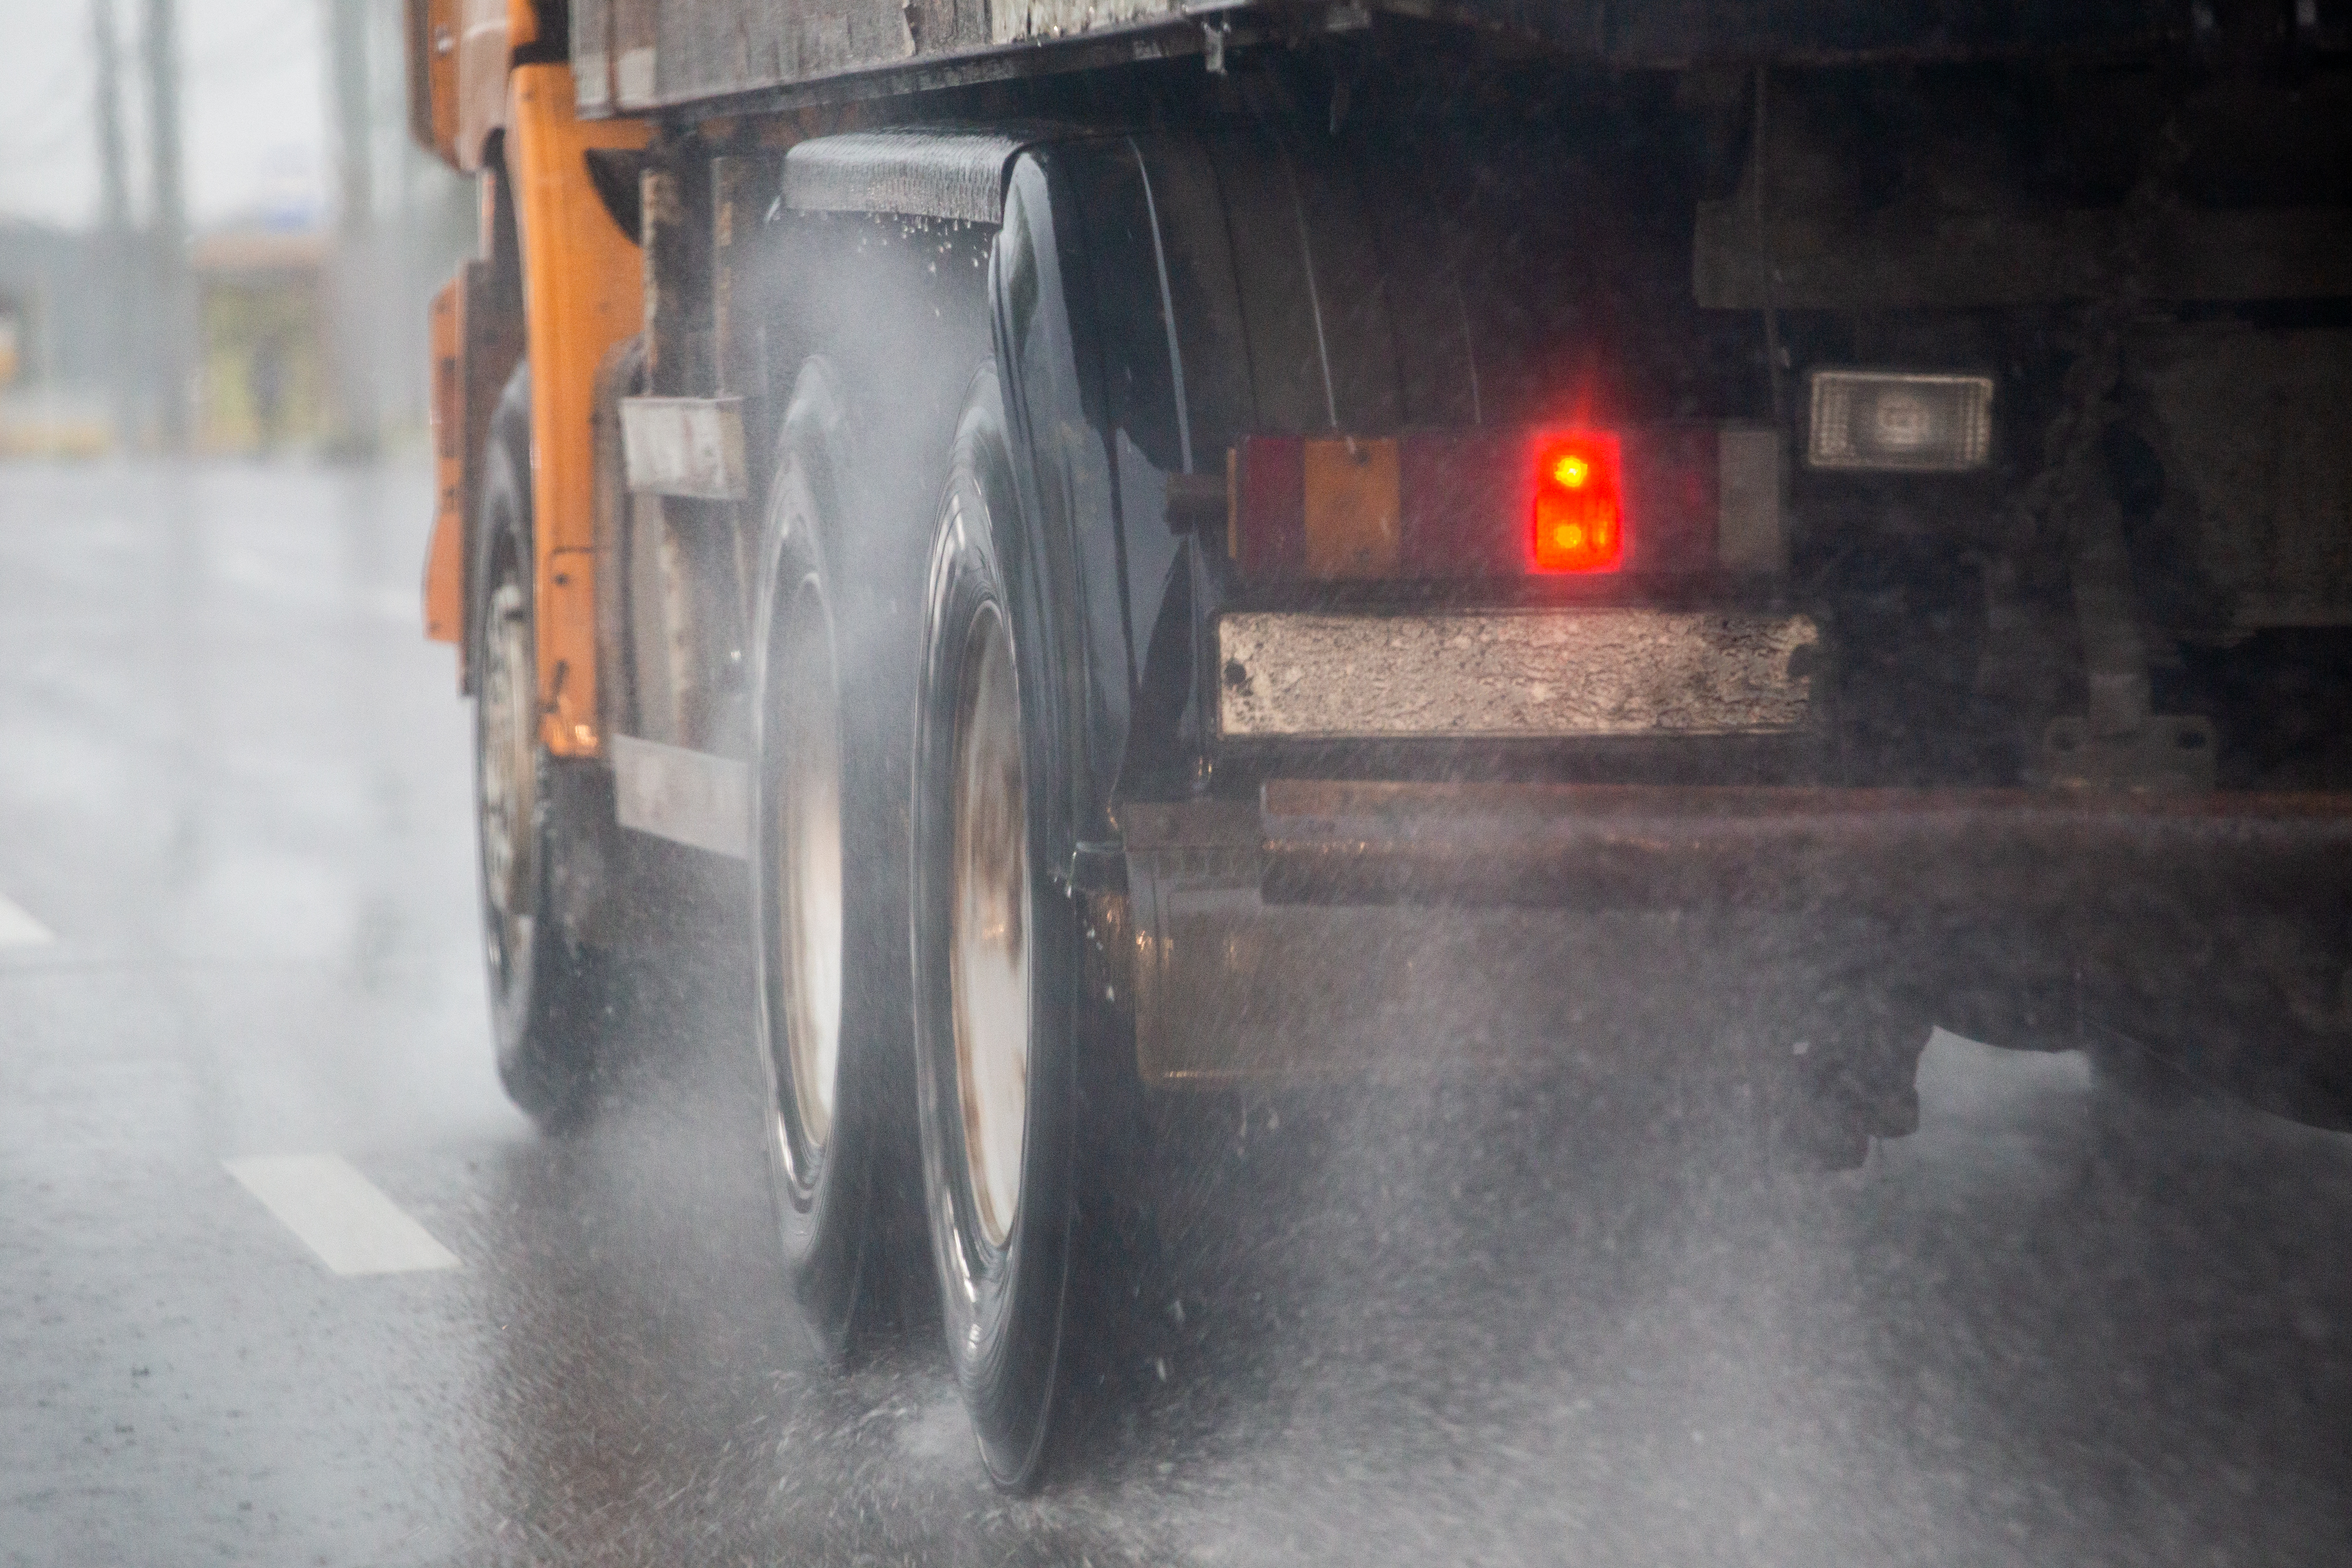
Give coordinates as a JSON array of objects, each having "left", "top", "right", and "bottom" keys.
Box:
[{"left": 948, "top": 604, "right": 1030, "bottom": 1248}]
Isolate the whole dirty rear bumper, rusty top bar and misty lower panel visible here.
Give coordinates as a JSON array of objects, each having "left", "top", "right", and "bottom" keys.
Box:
[{"left": 1120, "top": 781, "right": 2352, "bottom": 1100}]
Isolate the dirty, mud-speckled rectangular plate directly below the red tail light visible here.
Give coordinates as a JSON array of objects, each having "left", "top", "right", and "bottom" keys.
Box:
[{"left": 1216, "top": 609, "right": 1820, "bottom": 741}]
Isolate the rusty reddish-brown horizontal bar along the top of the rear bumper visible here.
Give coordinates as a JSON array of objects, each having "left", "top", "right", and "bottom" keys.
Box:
[{"left": 1261, "top": 781, "right": 2352, "bottom": 915}]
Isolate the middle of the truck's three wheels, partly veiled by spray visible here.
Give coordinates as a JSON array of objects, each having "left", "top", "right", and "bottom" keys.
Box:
[{"left": 750, "top": 364, "right": 910, "bottom": 1357}]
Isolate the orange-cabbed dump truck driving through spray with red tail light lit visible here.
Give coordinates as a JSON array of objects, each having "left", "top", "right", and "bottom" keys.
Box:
[{"left": 404, "top": 0, "right": 2352, "bottom": 1488}]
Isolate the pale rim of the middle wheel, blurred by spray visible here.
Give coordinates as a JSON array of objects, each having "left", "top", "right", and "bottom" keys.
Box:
[{"left": 776, "top": 581, "right": 842, "bottom": 1180}]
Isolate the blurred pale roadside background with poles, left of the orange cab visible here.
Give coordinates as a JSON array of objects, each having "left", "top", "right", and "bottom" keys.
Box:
[{"left": 0, "top": 0, "right": 475, "bottom": 461}]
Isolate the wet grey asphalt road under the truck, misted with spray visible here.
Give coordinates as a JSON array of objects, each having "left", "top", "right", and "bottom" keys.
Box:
[{"left": 0, "top": 466, "right": 2352, "bottom": 1568}]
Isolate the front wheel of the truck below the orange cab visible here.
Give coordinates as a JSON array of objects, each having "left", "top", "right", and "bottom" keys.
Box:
[{"left": 473, "top": 371, "right": 612, "bottom": 1131}]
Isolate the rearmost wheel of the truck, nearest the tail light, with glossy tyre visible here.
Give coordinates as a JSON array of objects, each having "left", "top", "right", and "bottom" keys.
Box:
[{"left": 915, "top": 371, "right": 1084, "bottom": 1488}]
